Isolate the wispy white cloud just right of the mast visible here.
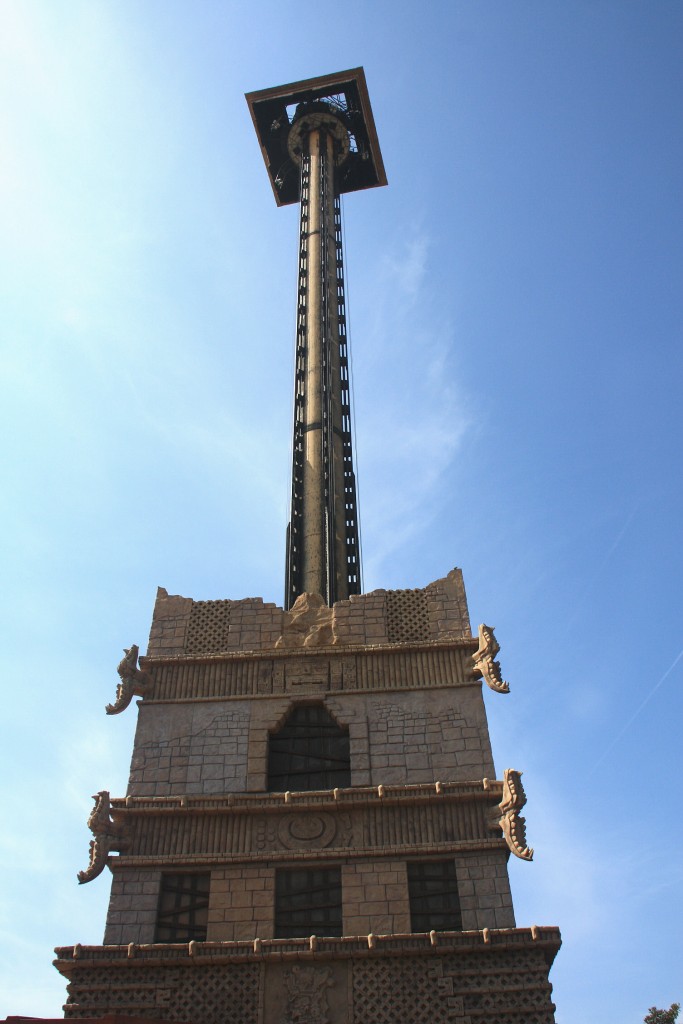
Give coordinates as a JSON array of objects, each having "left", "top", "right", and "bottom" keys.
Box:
[{"left": 356, "top": 227, "right": 470, "bottom": 580}]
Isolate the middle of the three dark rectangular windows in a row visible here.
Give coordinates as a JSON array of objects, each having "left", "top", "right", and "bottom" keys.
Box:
[{"left": 275, "top": 867, "right": 342, "bottom": 939}]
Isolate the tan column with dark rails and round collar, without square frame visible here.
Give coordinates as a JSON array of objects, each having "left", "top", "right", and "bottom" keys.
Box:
[{"left": 285, "top": 114, "right": 360, "bottom": 608}]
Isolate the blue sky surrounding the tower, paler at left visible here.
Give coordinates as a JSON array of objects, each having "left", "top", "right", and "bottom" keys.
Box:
[{"left": 0, "top": 0, "right": 683, "bottom": 1024}]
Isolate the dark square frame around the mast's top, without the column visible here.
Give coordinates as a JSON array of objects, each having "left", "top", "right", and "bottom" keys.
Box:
[{"left": 246, "top": 68, "right": 387, "bottom": 206}]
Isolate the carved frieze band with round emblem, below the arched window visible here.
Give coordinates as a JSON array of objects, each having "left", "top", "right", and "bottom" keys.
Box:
[{"left": 85, "top": 779, "right": 509, "bottom": 881}]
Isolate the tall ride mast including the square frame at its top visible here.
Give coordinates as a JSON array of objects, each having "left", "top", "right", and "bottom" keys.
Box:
[{"left": 247, "top": 68, "right": 386, "bottom": 608}]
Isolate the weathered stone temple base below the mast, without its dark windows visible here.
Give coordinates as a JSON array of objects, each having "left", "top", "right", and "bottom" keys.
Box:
[{"left": 66, "top": 569, "right": 559, "bottom": 1024}]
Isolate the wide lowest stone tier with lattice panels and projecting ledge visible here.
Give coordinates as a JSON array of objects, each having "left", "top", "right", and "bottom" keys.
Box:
[{"left": 54, "top": 928, "right": 561, "bottom": 1024}]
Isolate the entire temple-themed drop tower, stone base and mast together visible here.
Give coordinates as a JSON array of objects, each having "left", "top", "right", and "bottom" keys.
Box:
[{"left": 55, "top": 69, "right": 560, "bottom": 1024}]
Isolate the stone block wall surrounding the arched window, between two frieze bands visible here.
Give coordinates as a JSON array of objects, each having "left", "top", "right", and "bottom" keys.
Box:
[{"left": 128, "top": 684, "right": 495, "bottom": 797}]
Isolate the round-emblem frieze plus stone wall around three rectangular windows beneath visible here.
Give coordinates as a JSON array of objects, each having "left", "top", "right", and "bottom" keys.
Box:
[{"left": 97, "top": 780, "right": 515, "bottom": 943}]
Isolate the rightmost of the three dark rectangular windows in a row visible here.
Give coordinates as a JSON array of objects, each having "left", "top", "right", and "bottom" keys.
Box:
[{"left": 408, "top": 860, "right": 463, "bottom": 932}]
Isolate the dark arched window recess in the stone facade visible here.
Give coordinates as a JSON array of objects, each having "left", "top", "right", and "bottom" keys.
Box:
[{"left": 268, "top": 705, "right": 351, "bottom": 793}]
